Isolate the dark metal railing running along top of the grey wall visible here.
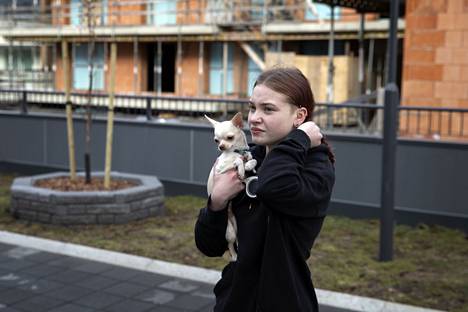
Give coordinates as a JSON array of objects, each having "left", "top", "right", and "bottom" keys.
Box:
[{"left": 0, "top": 90, "right": 468, "bottom": 141}]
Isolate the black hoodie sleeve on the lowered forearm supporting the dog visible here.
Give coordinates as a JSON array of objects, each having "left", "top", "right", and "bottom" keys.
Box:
[{"left": 195, "top": 198, "right": 227, "bottom": 257}]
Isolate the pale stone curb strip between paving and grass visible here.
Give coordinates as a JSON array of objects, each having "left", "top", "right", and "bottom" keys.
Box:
[{"left": 0, "top": 231, "right": 441, "bottom": 312}]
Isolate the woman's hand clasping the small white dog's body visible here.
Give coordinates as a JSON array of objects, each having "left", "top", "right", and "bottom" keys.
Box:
[{"left": 209, "top": 164, "right": 245, "bottom": 211}]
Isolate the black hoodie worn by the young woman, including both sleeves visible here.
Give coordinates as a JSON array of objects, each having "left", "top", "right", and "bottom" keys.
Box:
[{"left": 195, "top": 130, "right": 335, "bottom": 312}]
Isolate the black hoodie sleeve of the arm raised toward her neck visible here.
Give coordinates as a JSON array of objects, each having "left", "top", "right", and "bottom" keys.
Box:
[{"left": 257, "top": 129, "right": 335, "bottom": 217}]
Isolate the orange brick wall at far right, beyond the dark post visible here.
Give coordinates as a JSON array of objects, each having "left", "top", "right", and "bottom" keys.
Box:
[{"left": 401, "top": 0, "right": 468, "bottom": 136}]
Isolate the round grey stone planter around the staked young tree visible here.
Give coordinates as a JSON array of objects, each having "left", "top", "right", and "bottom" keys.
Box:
[{"left": 10, "top": 172, "right": 164, "bottom": 225}]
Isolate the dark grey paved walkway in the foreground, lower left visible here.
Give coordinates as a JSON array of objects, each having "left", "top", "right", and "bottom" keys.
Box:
[{"left": 0, "top": 243, "right": 351, "bottom": 312}]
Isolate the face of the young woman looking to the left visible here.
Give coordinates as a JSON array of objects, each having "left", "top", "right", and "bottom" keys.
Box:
[{"left": 249, "top": 85, "right": 298, "bottom": 151}]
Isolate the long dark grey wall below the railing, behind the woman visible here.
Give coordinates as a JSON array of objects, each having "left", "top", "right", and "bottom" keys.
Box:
[{"left": 0, "top": 112, "right": 468, "bottom": 231}]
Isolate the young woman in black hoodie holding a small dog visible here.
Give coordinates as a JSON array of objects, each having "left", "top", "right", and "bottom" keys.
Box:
[{"left": 195, "top": 68, "right": 335, "bottom": 312}]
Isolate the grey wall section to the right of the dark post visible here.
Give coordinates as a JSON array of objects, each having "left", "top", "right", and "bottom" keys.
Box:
[{"left": 396, "top": 143, "right": 468, "bottom": 214}]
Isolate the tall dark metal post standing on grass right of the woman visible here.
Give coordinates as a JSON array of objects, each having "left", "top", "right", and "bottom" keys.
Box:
[{"left": 379, "top": 1, "right": 400, "bottom": 261}]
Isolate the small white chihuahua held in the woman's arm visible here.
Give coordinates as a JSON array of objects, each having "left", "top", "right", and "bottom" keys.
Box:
[{"left": 205, "top": 113, "right": 257, "bottom": 261}]
